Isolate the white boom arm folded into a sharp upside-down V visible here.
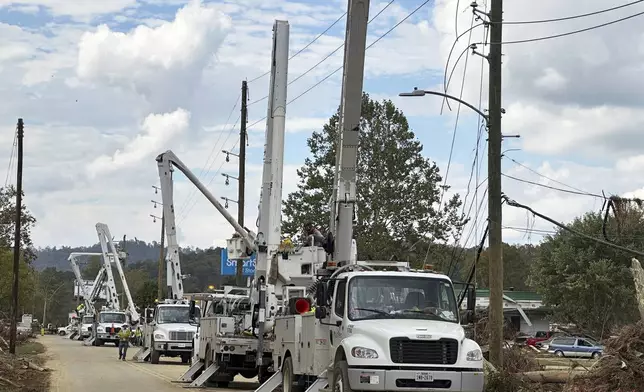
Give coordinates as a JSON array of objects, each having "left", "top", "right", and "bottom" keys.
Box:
[{"left": 157, "top": 150, "right": 256, "bottom": 251}]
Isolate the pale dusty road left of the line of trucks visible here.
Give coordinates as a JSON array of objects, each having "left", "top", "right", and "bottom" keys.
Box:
[{"left": 38, "top": 335, "right": 256, "bottom": 392}]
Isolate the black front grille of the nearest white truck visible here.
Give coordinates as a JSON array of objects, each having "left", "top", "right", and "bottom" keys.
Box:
[{"left": 389, "top": 337, "right": 458, "bottom": 365}]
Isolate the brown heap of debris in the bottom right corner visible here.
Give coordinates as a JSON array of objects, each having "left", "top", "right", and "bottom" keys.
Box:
[{"left": 566, "top": 322, "right": 644, "bottom": 392}]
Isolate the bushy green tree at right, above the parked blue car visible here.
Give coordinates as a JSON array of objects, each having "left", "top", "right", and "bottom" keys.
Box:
[{"left": 531, "top": 208, "right": 644, "bottom": 337}]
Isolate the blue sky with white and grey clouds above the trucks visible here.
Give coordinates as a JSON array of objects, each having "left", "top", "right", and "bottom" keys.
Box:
[{"left": 0, "top": 0, "right": 644, "bottom": 248}]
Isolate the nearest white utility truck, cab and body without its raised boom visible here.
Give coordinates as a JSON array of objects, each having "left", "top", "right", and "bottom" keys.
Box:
[{"left": 270, "top": 262, "right": 484, "bottom": 392}]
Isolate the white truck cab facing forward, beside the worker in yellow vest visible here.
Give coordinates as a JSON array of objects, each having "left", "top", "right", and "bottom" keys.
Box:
[{"left": 145, "top": 303, "right": 200, "bottom": 364}]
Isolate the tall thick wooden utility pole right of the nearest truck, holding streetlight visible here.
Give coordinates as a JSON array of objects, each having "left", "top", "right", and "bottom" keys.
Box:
[{"left": 488, "top": 0, "right": 503, "bottom": 368}]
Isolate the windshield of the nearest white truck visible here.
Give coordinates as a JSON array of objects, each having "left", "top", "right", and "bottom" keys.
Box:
[{"left": 348, "top": 276, "right": 458, "bottom": 323}]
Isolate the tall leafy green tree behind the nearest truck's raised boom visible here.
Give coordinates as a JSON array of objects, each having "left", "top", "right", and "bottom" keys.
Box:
[{"left": 283, "top": 94, "right": 464, "bottom": 259}]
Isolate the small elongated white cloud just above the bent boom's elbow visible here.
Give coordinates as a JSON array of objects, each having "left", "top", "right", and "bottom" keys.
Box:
[{"left": 87, "top": 108, "right": 190, "bottom": 178}]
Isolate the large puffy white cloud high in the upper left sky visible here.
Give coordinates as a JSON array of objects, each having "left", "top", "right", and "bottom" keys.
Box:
[{"left": 77, "top": 0, "right": 232, "bottom": 110}]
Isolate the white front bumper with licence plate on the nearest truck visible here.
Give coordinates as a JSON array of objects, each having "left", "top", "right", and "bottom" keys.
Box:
[{"left": 349, "top": 368, "right": 484, "bottom": 392}]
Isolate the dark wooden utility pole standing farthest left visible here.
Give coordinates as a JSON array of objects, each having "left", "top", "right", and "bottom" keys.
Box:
[{"left": 9, "top": 118, "right": 25, "bottom": 354}]
